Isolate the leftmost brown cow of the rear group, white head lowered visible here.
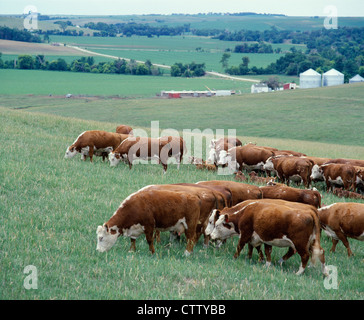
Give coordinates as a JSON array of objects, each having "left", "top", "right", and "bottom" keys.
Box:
[{"left": 65, "top": 130, "right": 129, "bottom": 162}]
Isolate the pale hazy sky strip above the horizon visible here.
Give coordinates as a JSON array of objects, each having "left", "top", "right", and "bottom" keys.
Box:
[{"left": 0, "top": 0, "right": 364, "bottom": 17}]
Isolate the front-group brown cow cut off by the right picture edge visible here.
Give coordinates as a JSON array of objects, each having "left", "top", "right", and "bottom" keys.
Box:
[{"left": 318, "top": 202, "right": 364, "bottom": 257}]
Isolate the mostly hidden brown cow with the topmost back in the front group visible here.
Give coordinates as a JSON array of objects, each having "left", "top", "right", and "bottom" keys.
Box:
[{"left": 197, "top": 180, "right": 263, "bottom": 206}]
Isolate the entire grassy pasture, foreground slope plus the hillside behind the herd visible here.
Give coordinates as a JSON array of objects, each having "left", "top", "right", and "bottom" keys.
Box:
[{"left": 0, "top": 77, "right": 364, "bottom": 300}]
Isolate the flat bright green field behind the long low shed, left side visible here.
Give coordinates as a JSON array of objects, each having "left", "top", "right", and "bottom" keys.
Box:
[{"left": 0, "top": 69, "right": 251, "bottom": 98}]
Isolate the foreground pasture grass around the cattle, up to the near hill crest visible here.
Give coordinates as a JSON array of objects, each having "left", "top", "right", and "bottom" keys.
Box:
[{"left": 0, "top": 108, "right": 364, "bottom": 300}]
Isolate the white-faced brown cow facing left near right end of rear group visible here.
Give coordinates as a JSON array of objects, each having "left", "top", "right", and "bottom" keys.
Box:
[{"left": 311, "top": 163, "right": 356, "bottom": 192}]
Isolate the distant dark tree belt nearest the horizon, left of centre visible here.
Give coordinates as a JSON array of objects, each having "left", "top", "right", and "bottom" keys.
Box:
[{"left": 83, "top": 22, "right": 190, "bottom": 37}]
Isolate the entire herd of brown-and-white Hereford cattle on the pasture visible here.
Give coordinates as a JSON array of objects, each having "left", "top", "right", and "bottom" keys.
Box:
[{"left": 65, "top": 125, "right": 364, "bottom": 275}]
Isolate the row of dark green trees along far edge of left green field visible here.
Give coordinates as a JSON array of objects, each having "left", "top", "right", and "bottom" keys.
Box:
[{"left": 0, "top": 53, "right": 161, "bottom": 75}]
